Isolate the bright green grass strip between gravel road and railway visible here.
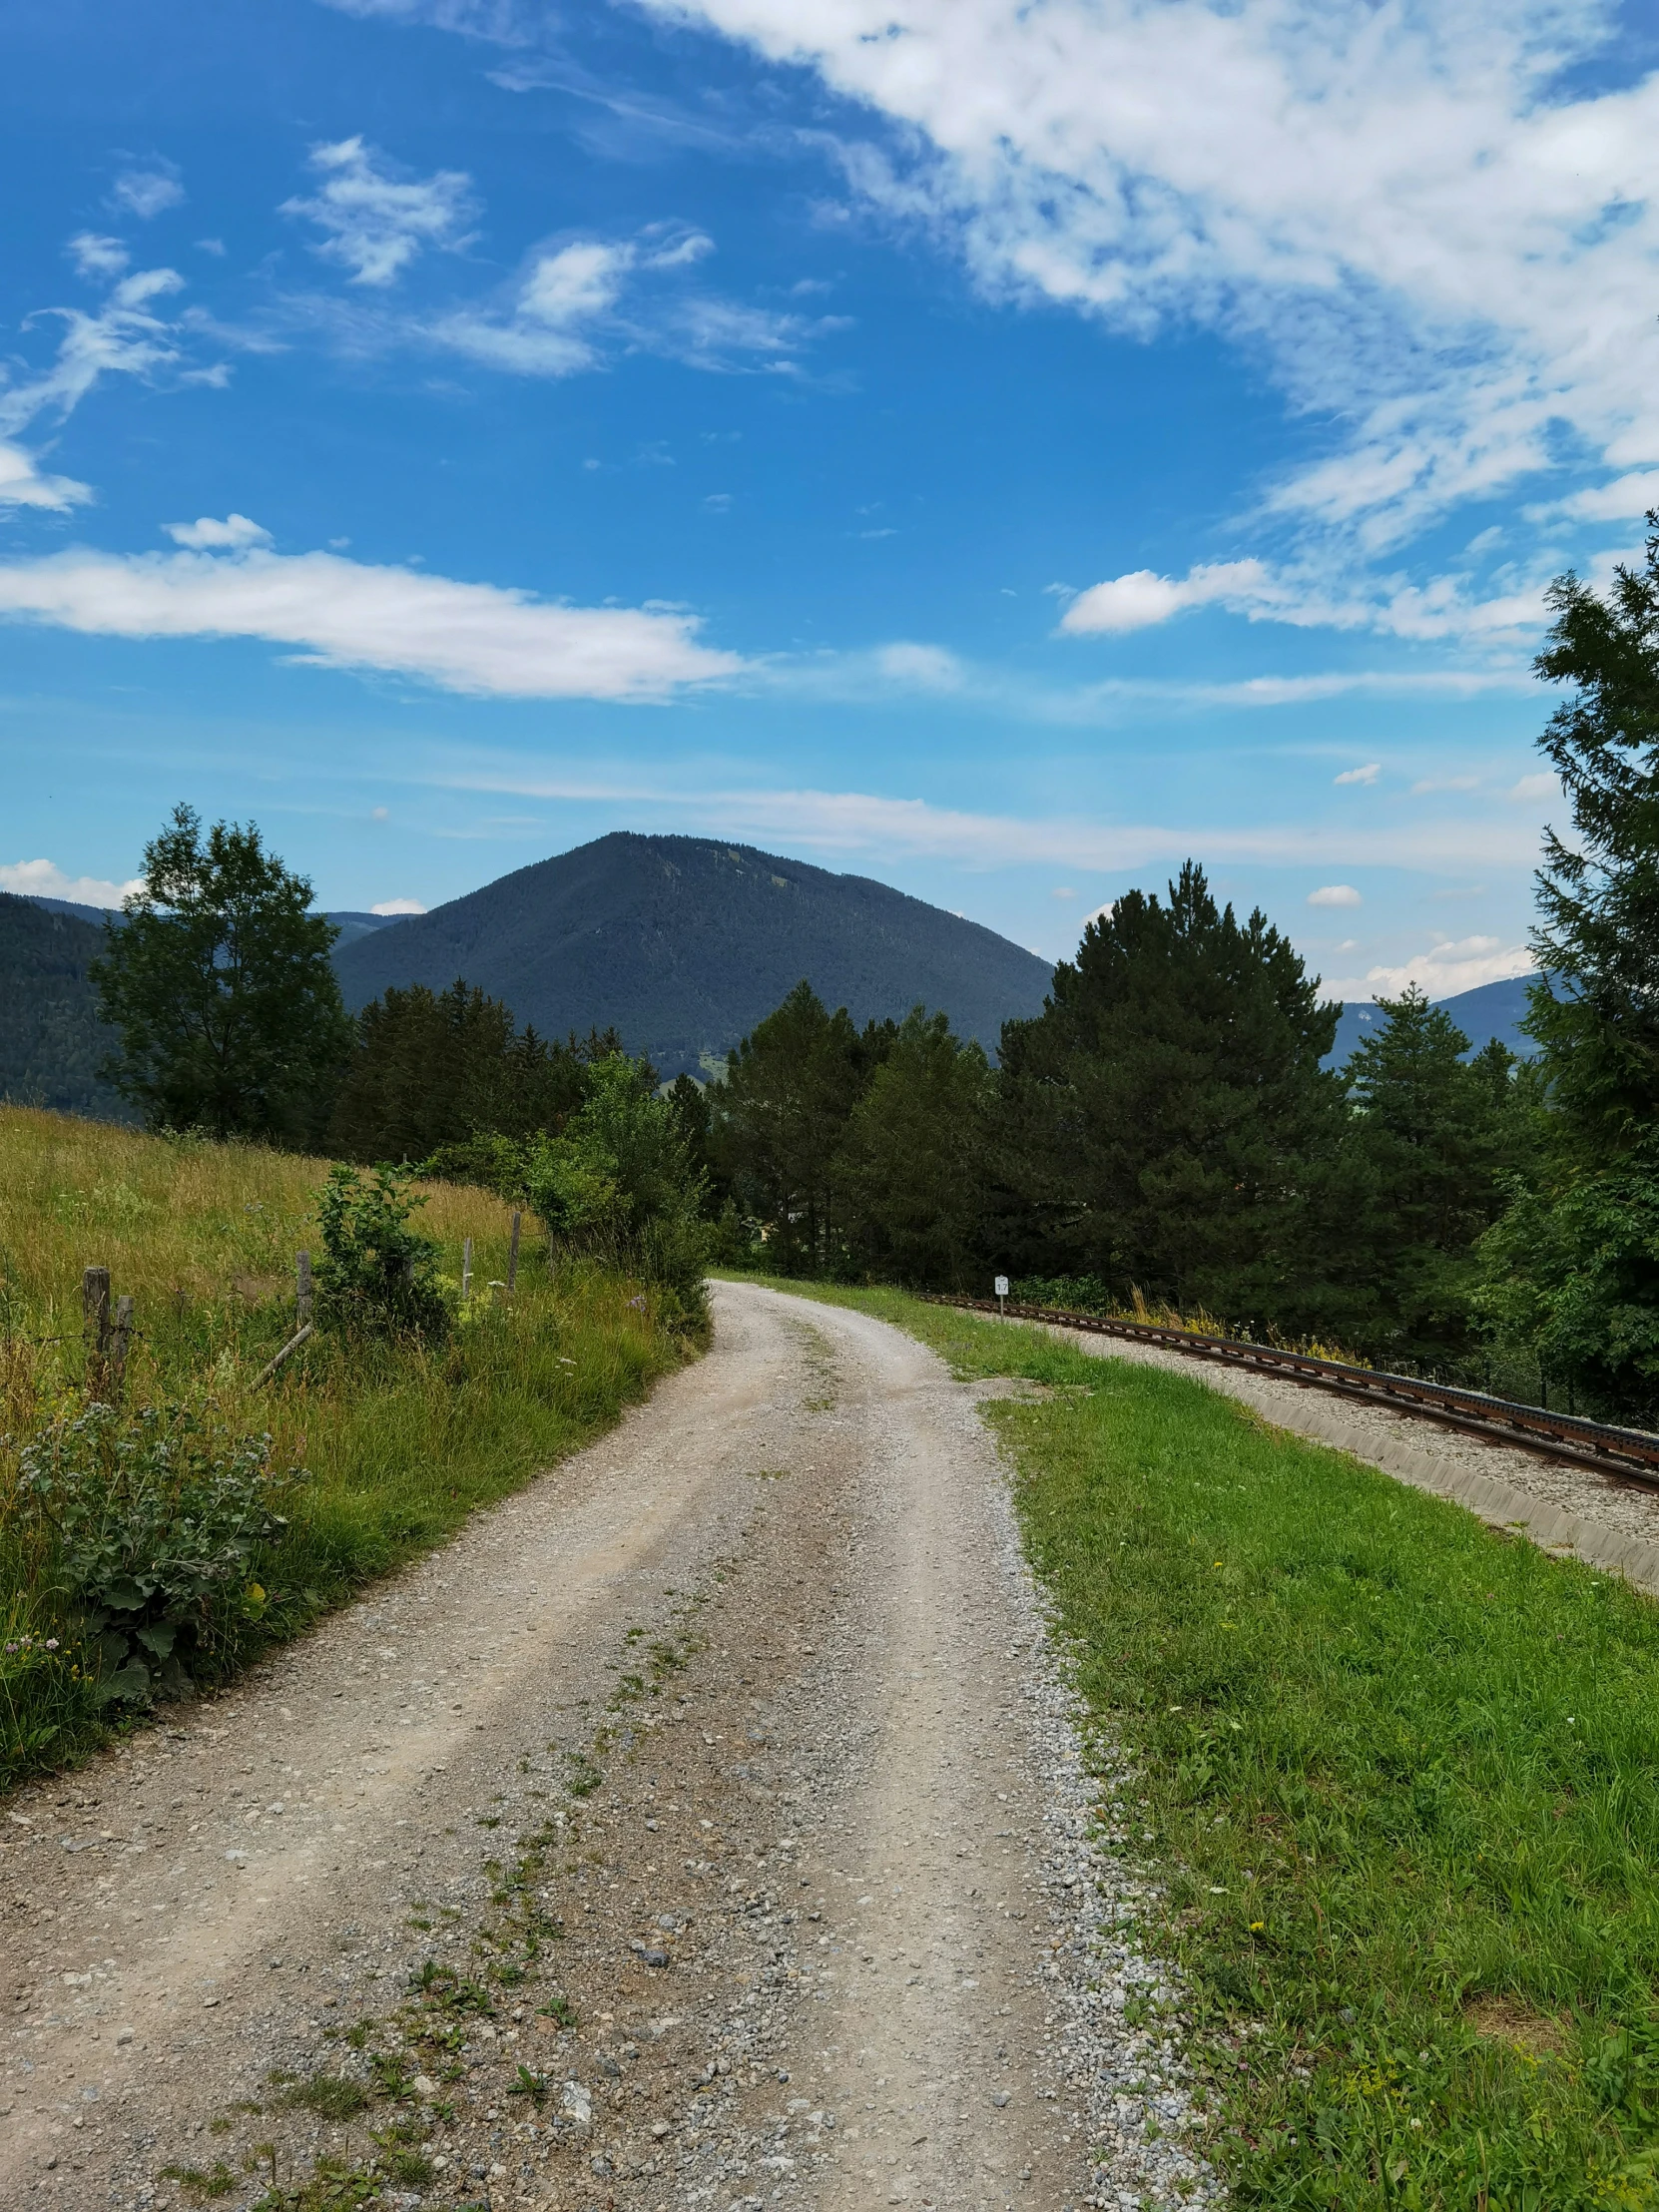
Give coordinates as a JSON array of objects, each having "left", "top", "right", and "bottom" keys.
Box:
[{"left": 730, "top": 1283, "right": 1659, "bottom": 2212}]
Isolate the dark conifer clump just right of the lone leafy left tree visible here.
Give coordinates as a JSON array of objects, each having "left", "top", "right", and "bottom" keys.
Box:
[{"left": 329, "top": 980, "right": 606, "bottom": 1181}]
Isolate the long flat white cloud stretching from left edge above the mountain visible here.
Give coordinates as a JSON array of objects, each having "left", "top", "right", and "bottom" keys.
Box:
[{"left": 0, "top": 546, "right": 744, "bottom": 699}]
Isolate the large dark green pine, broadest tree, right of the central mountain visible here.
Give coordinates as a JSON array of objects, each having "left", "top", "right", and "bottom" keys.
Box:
[{"left": 1000, "top": 860, "right": 1341, "bottom": 1328}]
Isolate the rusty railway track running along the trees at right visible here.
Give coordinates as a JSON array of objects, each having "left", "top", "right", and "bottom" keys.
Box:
[{"left": 929, "top": 1292, "right": 1659, "bottom": 1488}]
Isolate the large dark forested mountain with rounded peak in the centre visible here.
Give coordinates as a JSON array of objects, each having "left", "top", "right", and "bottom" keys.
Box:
[{"left": 336, "top": 831, "right": 1051, "bottom": 1075}]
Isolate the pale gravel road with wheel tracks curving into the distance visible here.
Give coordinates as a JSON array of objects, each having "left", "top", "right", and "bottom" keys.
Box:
[{"left": 0, "top": 1285, "right": 1217, "bottom": 2212}]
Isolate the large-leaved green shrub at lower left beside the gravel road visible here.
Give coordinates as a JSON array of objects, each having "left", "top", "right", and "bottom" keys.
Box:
[{"left": 18, "top": 1404, "right": 307, "bottom": 1699}]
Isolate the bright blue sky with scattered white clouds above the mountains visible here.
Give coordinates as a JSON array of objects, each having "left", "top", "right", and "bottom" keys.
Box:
[{"left": 0, "top": 0, "right": 1659, "bottom": 995}]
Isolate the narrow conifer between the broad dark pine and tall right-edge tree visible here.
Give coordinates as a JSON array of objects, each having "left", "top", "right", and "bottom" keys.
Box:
[{"left": 1343, "top": 989, "right": 1524, "bottom": 1363}]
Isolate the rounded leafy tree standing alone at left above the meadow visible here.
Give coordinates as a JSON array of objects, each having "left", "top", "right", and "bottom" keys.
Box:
[{"left": 95, "top": 806, "right": 349, "bottom": 1144}]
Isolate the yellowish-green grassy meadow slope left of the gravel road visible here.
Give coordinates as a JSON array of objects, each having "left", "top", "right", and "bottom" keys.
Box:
[{"left": 0, "top": 1108, "right": 686, "bottom": 1783}]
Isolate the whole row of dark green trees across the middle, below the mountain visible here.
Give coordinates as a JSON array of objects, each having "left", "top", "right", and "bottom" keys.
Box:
[{"left": 88, "top": 513, "right": 1659, "bottom": 1417}]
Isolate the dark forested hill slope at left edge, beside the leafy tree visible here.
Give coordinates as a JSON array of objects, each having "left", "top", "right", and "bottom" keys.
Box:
[{"left": 0, "top": 891, "right": 131, "bottom": 1122}]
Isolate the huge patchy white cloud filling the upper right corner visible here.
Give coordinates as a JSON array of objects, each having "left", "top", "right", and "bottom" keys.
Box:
[{"left": 641, "top": 0, "right": 1659, "bottom": 561}]
